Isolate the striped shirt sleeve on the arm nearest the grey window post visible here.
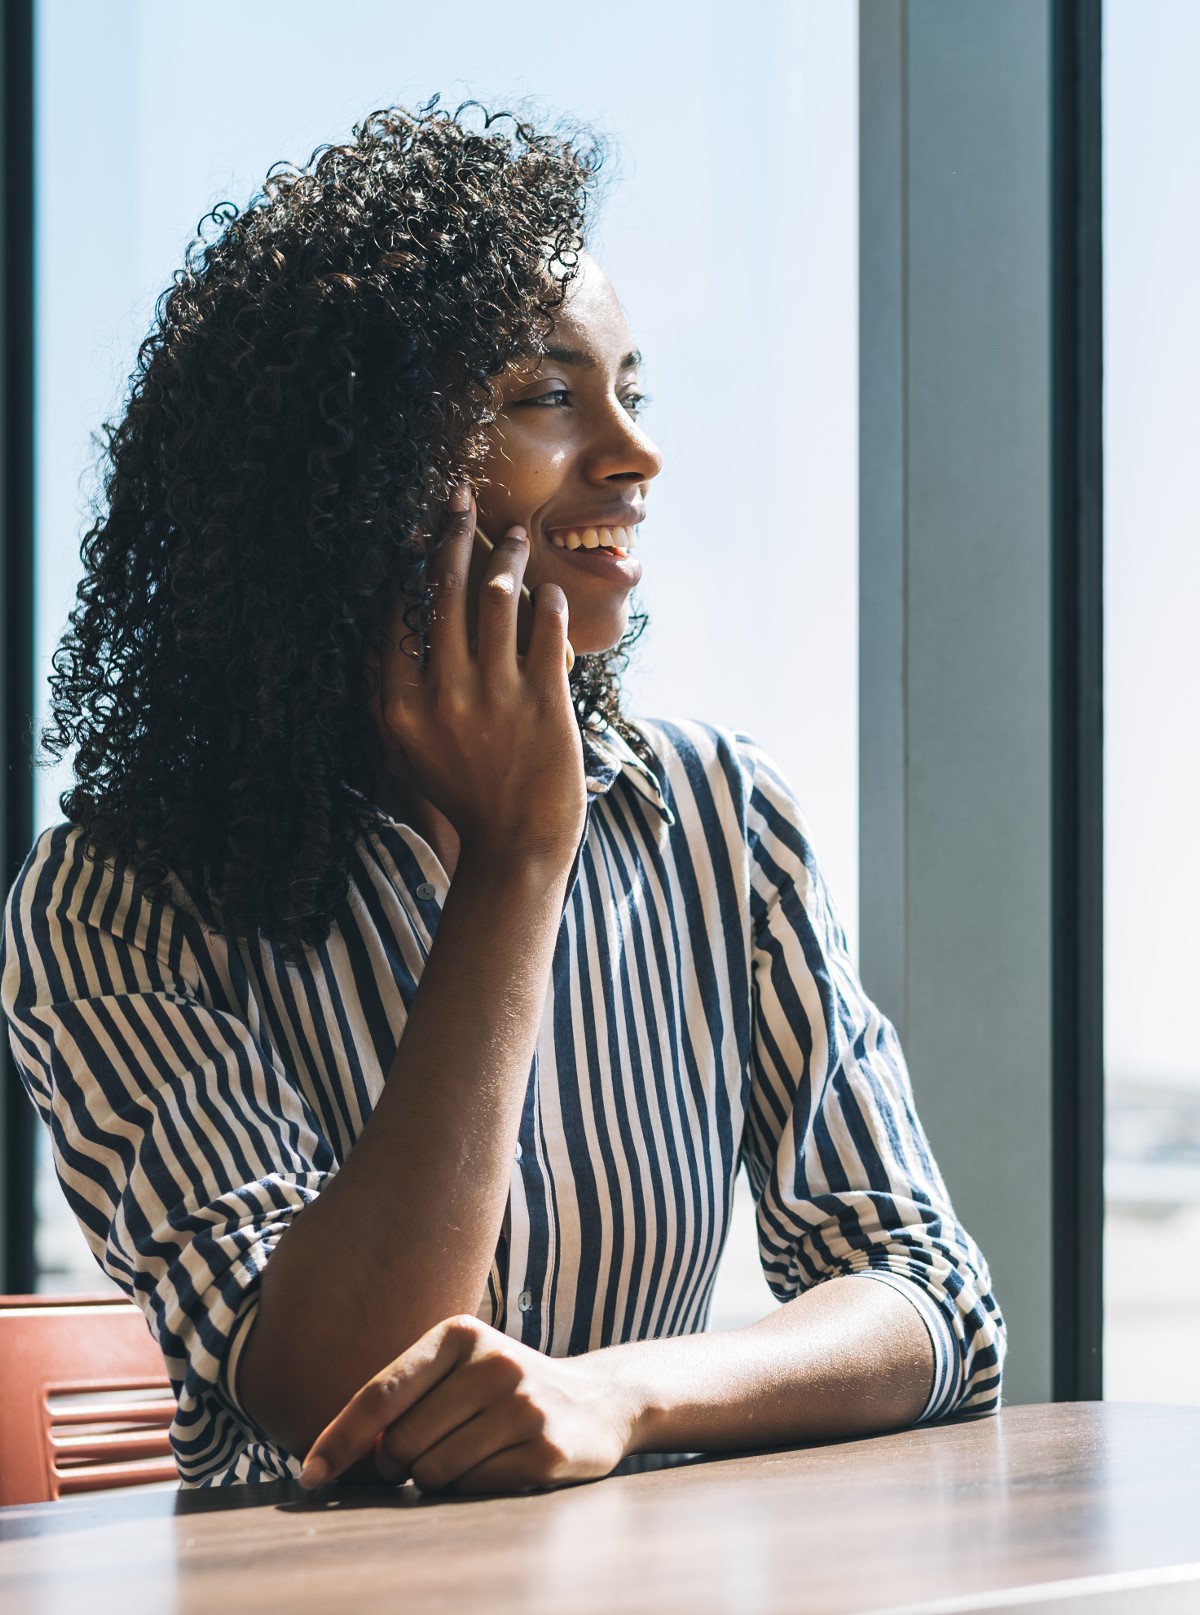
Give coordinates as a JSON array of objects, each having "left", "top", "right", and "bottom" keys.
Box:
[{"left": 741, "top": 736, "right": 1005, "bottom": 1420}]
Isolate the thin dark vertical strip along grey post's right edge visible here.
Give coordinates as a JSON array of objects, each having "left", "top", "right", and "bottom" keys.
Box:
[{"left": 1051, "top": 0, "right": 1105, "bottom": 1400}]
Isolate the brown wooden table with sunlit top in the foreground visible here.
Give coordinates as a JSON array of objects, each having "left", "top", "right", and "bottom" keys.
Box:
[{"left": 0, "top": 1402, "right": 1200, "bottom": 1615}]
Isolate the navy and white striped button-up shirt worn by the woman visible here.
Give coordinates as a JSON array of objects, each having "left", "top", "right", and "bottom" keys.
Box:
[{"left": 0, "top": 720, "right": 1005, "bottom": 1484}]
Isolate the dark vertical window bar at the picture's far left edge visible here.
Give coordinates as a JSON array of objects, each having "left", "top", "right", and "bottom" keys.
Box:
[{"left": 0, "top": 0, "right": 36, "bottom": 1292}]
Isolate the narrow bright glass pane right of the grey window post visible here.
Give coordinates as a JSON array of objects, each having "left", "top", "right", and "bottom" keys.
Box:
[{"left": 1103, "top": 0, "right": 1200, "bottom": 1402}]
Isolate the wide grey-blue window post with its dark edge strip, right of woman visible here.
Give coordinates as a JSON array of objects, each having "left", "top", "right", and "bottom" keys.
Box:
[{"left": 859, "top": 0, "right": 1105, "bottom": 1402}]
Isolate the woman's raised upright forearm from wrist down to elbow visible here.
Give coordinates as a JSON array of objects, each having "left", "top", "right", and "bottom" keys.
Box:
[{"left": 237, "top": 848, "right": 570, "bottom": 1452}]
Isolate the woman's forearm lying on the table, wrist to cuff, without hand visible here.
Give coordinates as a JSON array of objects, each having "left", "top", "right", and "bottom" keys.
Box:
[{"left": 593, "top": 1274, "right": 935, "bottom": 1454}]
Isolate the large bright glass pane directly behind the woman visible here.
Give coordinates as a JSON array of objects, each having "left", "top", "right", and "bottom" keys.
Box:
[{"left": 37, "top": 0, "right": 858, "bottom": 1323}]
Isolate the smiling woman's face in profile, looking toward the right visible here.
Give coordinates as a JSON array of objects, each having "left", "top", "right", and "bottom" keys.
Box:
[{"left": 476, "top": 255, "right": 662, "bottom": 652}]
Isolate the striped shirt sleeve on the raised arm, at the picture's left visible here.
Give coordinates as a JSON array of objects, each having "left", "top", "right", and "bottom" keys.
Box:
[{"left": 0, "top": 825, "right": 336, "bottom": 1484}]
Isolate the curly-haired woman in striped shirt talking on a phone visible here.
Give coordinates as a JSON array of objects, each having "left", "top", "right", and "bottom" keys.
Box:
[{"left": 3, "top": 99, "right": 1005, "bottom": 1492}]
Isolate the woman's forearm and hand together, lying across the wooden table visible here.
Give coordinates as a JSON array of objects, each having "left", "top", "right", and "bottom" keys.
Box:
[{"left": 302, "top": 1276, "right": 935, "bottom": 1492}]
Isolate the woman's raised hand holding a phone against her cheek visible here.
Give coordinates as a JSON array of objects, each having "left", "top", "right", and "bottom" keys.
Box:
[{"left": 368, "top": 483, "right": 586, "bottom": 861}]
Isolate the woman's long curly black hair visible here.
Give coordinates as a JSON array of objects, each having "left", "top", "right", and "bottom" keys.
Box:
[{"left": 42, "top": 95, "right": 644, "bottom": 956}]
